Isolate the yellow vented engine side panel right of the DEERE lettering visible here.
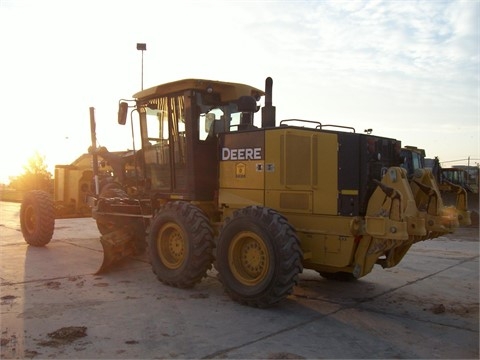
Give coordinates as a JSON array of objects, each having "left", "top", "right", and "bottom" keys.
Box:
[{"left": 265, "top": 129, "right": 338, "bottom": 215}]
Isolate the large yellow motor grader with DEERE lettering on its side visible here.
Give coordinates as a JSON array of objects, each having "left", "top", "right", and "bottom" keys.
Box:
[{"left": 18, "top": 78, "right": 459, "bottom": 307}]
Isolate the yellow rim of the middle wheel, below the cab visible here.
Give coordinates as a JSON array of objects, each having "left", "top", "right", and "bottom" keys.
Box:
[{"left": 157, "top": 223, "right": 187, "bottom": 269}]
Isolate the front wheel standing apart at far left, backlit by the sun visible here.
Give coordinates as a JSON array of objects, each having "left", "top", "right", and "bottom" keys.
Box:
[{"left": 20, "top": 190, "right": 55, "bottom": 246}]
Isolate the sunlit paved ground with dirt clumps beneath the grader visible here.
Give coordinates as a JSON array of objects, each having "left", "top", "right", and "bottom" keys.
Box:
[{"left": 0, "top": 202, "right": 479, "bottom": 359}]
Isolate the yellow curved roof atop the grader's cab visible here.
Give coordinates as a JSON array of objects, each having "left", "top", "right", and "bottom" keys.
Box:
[{"left": 133, "top": 79, "right": 265, "bottom": 102}]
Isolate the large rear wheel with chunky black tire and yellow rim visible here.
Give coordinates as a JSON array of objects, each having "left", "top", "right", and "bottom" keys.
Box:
[{"left": 215, "top": 206, "right": 303, "bottom": 308}]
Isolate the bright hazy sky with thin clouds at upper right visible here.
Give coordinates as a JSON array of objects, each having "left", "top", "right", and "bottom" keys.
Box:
[{"left": 0, "top": 0, "right": 480, "bottom": 183}]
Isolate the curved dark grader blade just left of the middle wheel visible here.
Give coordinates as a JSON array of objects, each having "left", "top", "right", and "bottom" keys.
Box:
[{"left": 95, "top": 229, "right": 135, "bottom": 275}]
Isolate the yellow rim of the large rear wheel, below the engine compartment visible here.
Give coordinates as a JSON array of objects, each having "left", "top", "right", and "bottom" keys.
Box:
[{"left": 228, "top": 231, "right": 270, "bottom": 286}]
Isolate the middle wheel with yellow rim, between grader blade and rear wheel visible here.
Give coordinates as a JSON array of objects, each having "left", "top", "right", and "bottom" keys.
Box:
[{"left": 148, "top": 201, "right": 215, "bottom": 288}]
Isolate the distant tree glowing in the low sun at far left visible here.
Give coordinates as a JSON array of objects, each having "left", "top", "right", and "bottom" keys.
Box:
[{"left": 10, "top": 151, "right": 53, "bottom": 192}]
